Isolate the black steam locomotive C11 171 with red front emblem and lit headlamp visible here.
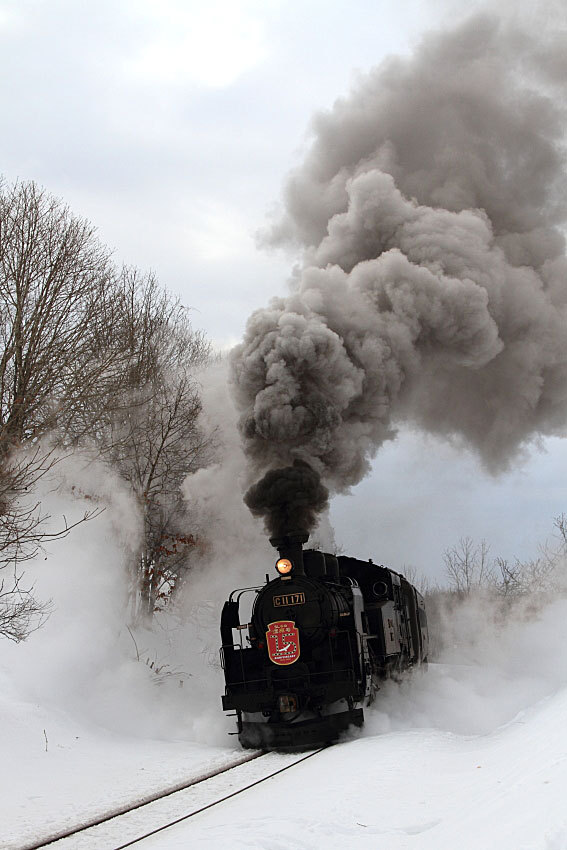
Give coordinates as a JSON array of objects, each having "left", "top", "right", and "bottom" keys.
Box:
[{"left": 221, "top": 532, "right": 428, "bottom": 749}]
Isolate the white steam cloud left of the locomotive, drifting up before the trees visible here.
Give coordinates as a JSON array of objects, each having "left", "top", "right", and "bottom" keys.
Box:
[{"left": 0, "top": 455, "right": 235, "bottom": 746}]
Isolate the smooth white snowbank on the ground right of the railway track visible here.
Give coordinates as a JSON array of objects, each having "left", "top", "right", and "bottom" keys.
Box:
[{"left": 144, "top": 691, "right": 567, "bottom": 850}]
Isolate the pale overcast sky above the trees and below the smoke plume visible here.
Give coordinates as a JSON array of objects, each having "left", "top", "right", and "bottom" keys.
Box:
[{"left": 0, "top": 0, "right": 567, "bottom": 575}]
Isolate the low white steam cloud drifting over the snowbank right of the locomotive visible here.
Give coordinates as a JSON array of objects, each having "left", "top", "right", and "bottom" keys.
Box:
[{"left": 362, "top": 595, "right": 567, "bottom": 735}]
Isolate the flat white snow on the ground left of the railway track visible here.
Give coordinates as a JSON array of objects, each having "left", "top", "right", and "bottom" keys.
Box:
[{"left": 0, "top": 678, "right": 239, "bottom": 850}]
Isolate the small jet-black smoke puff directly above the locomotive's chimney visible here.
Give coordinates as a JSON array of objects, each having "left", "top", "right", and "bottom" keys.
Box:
[{"left": 244, "top": 459, "right": 329, "bottom": 537}]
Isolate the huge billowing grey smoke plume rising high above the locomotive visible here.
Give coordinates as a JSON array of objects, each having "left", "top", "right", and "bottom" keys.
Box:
[{"left": 233, "top": 11, "right": 567, "bottom": 530}]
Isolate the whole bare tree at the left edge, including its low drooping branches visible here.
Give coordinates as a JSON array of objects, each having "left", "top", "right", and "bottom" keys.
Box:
[{"left": 0, "top": 180, "right": 123, "bottom": 640}]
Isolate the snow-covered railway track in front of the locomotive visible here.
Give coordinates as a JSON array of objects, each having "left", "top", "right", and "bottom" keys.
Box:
[{"left": 16, "top": 748, "right": 324, "bottom": 850}]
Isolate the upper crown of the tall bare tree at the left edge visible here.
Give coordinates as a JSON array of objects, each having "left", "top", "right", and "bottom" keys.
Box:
[{"left": 0, "top": 178, "right": 125, "bottom": 450}]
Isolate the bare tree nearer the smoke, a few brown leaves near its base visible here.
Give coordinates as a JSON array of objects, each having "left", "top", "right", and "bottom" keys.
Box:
[{"left": 93, "top": 269, "right": 213, "bottom": 615}]
